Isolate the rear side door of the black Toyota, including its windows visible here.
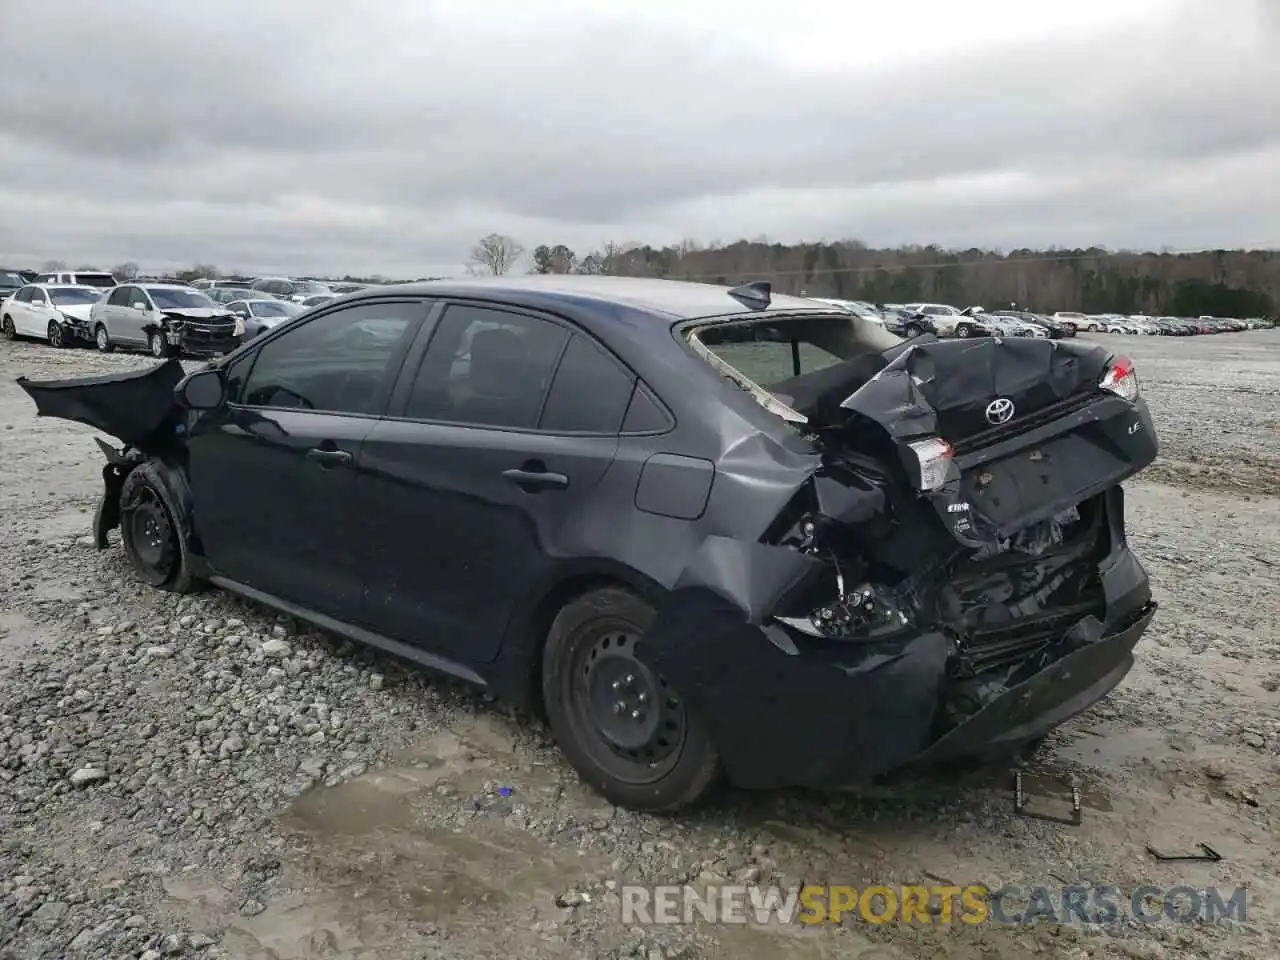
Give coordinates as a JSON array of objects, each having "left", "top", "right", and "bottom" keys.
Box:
[{"left": 356, "top": 303, "right": 635, "bottom": 663}]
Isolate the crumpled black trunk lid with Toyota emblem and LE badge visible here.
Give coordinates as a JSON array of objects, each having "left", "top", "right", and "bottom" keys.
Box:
[{"left": 841, "top": 338, "right": 1158, "bottom": 548}]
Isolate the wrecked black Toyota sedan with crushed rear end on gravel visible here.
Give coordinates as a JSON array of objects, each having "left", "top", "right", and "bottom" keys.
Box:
[{"left": 20, "top": 276, "right": 1157, "bottom": 810}]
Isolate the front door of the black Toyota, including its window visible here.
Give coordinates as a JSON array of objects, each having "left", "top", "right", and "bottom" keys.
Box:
[{"left": 187, "top": 300, "right": 426, "bottom": 621}]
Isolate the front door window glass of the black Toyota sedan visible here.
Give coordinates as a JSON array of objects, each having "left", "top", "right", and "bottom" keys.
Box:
[{"left": 239, "top": 303, "right": 425, "bottom": 413}]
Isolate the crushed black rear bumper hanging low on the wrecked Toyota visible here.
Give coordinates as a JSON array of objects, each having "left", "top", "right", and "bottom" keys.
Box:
[{"left": 637, "top": 490, "right": 1156, "bottom": 788}]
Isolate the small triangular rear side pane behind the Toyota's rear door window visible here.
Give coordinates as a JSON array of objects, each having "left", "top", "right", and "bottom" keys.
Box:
[{"left": 538, "top": 334, "right": 635, "bottom": 434}]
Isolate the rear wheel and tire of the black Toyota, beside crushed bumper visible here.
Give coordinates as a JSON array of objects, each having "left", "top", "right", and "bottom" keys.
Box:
[{"left": 543, "top": 588, "right": 721, "bottom": 813}]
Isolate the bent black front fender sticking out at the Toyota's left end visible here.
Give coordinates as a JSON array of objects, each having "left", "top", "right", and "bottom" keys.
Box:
[{"left": 18, "top": 360, "right": 186, "bottom": 447}]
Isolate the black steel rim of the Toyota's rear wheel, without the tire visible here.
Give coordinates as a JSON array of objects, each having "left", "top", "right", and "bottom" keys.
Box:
[{"left": 572, "top": 625, "right": 686, "bottom": 783}]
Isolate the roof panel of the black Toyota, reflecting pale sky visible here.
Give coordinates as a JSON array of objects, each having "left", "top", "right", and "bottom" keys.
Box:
[{"left": 343, "top": 274, "right": 831, "bottom": 320}]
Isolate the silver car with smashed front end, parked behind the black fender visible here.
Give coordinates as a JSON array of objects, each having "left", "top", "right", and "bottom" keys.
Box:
[{"left": 88, "top": 283, "right": 244, "bottom": 357}]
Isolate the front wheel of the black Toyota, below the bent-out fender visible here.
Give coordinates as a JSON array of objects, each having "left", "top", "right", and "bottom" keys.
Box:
[{"left": 120, "top": 462, "right": 196, "bottom": 594}]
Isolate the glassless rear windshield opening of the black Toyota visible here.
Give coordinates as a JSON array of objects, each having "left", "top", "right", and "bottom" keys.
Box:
[{"left": 687, "top": 314, "right": 901, "bottom": 426}]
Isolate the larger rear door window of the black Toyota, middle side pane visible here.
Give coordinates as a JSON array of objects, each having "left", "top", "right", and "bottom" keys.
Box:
[{"left": 404, "top": 306, "right": 568, "bottom": 430}]
